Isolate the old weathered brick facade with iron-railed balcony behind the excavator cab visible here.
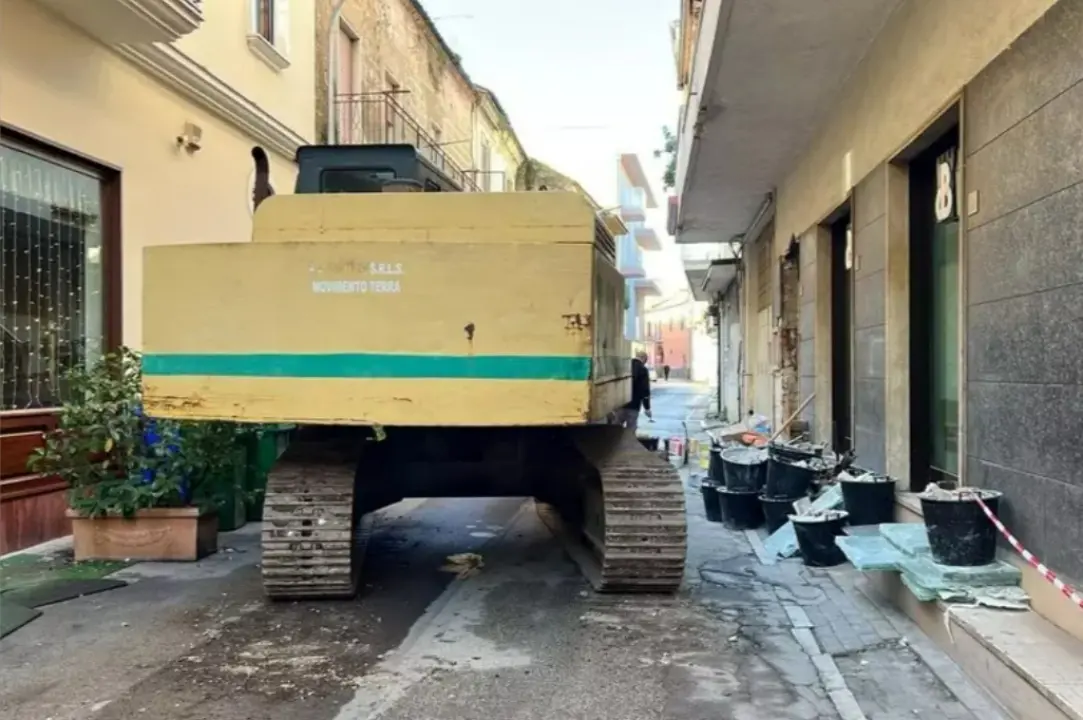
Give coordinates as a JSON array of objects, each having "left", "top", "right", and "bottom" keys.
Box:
[{"left": 315, "top": 0, "right": 526, "bottom": 191}]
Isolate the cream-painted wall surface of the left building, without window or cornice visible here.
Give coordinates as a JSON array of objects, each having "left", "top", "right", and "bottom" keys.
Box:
[{"left": 0, "top": 0, "right": 312, "bottom": 348}]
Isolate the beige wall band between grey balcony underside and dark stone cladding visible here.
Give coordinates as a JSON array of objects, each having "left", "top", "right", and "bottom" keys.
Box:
[{"left": 774, "top": 0, "right": 1055, "bottom": 252}]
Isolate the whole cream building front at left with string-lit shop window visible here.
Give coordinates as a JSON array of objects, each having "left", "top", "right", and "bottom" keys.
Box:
[{"left": 0, "top": 0, "right": 315, "bottom": 552}]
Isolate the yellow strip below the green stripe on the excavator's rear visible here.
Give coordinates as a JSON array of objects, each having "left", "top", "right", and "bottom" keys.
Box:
[{"left": 144, "top": 377, "right": 590, "bottom": 427}]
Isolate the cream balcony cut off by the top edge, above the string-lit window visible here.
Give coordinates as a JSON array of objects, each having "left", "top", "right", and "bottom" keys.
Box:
[{"left": 38, "top": 0, "right": 204, "bottom": 45}]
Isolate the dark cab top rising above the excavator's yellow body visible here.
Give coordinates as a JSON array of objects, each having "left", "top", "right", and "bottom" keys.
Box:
[{"left": 293, "top": 145, "right": 462, "bottom": 195}]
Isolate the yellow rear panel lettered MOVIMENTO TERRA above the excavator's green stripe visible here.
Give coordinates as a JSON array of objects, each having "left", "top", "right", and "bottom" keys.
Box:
[{"left": 143, "top": 238, "right": 592, "bottom": 355}]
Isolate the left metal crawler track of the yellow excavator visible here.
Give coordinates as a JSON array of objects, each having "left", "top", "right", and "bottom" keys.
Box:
[{"left": 262, "top": 438, "right": 373, "bottom": 600}]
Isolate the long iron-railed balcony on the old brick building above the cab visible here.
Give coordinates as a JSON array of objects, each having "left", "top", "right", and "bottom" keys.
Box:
[{"left": 335, "top": 90, "right": 481, "bottom": 193}]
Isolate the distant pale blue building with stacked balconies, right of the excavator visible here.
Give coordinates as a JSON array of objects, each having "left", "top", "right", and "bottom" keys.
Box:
[{"left": 616, "top": 153, "right": 662, "bottom": 344}]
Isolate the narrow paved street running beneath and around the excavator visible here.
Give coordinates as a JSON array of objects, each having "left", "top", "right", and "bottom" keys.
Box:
[{"left": 0, "top": 383, "right": 1000, "bottom": 720}]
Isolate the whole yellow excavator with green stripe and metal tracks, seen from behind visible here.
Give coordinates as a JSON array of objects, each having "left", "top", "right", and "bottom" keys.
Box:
[{"left": 143, "top": 145, "right": 687, "bottom": 599}]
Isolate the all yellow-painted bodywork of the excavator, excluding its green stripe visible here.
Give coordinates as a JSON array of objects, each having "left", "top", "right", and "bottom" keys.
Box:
[{"left": 143, "top": 193, "right": 630, "bottom": 426}]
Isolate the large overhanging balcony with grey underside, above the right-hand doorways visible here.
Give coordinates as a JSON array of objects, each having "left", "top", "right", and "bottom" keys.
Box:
[{"left": 676, "top": 0, "right": 905, "bottom": 244}]
